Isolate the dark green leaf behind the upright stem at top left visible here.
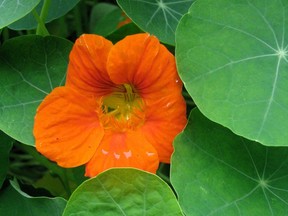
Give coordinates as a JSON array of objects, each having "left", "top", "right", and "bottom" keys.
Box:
[{"left": 8, "top": 0, "right": 80, "bottom": 30}]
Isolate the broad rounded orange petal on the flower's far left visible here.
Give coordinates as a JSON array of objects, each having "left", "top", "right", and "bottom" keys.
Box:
[{"left": 33, "top": 87, "right": 104, "bottom": 167}]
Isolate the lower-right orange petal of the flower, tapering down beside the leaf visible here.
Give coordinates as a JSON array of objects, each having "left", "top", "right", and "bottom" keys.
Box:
[{"left": 141, "top": 94, "right": 187, "bottom": 163}]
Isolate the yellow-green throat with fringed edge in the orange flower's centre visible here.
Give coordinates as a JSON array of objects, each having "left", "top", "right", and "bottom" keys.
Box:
[{"left": 100, "top": 84, "right": 145, "bottom": 131}]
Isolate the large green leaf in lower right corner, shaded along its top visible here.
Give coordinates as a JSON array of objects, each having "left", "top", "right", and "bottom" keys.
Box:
[{"left": 171, "top": 109, "right": 288, "bottom": 216}]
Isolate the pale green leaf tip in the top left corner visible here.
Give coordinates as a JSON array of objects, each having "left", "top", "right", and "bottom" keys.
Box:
[{"left": 0, "top": 0, "right": 40, "bottom": 29}]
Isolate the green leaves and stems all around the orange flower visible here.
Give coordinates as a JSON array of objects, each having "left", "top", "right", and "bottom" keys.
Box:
[{"left": 0, "top": 0, "right": 288, "bottom": 216}]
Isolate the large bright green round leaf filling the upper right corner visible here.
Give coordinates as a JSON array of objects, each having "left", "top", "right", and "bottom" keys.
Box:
[{"left": 176, "top": 0, "right": 288, "bottom": 146}]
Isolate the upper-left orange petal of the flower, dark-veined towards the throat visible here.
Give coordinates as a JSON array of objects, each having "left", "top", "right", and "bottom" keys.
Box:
[{"left": 66, "top": 34, "right": 114, "bottom": 96}]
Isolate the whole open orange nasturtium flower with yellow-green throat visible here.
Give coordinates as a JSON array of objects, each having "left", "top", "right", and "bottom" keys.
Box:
[{"left": 34, "top": 33, "right": 187, "bottom": 177}]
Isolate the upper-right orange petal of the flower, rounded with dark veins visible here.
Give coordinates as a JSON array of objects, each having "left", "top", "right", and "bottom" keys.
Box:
[{"left": 107, "top": 33, "right": 182, "bottom": 98}]
